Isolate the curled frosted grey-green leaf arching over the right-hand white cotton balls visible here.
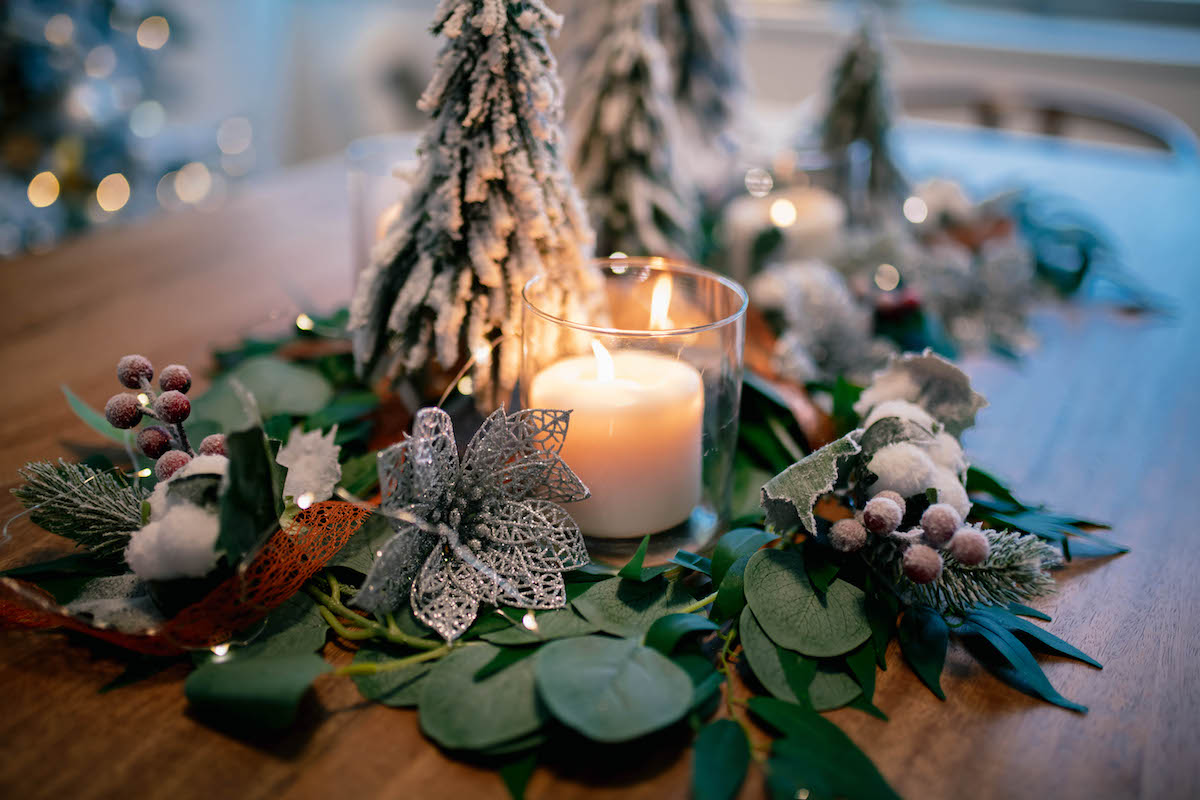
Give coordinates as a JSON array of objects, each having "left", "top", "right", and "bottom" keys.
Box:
[{"left": 854, "top": 349, "right": 988, "bottom": 437}]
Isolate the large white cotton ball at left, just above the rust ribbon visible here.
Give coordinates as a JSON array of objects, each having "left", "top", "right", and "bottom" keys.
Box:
[{"left": 125, "top": 504, "right": 221, "bottom": 581}]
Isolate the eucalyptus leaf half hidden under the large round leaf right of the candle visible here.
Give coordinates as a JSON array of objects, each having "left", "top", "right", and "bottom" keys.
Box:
[{"left": 738, "top": 608, "right": 863, "bottom": 711}]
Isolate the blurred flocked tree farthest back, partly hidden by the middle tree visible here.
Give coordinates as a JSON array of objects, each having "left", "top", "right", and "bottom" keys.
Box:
[{"left": 658, "top": 0, "right": 744, "bottom": 157}]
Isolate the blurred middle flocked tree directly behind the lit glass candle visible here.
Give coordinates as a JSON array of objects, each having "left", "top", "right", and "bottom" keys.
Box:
[{"left": 569, "top": 0, "right": 695, "bottom": 257}]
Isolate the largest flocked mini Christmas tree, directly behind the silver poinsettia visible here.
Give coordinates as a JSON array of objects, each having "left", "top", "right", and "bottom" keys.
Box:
[{"left": 350, "top": 0, "right": 599, "bottom": 407}]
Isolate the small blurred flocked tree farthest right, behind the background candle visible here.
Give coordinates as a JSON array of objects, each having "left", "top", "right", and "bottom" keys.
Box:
[{"left": 821, "top": 20, "right": 905, "bottom": 194}]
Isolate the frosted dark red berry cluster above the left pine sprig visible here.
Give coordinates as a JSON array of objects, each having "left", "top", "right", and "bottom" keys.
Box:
[{"left": 104, "top": 355, "right": 226, "bottom": 481}]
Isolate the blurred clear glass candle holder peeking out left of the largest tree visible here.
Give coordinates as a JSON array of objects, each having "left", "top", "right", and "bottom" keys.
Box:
[{"left": 346, "top": 133, "right": 421, "bottom": 279}]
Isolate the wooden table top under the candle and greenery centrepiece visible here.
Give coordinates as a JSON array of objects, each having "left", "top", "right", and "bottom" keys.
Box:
[{"left": 0, "top": 132, "right": 1200, "bottom": 800}]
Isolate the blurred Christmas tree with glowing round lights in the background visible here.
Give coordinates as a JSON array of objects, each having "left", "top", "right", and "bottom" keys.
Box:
[{"left": 0, "top": 0, "right": 254, "bottom": 258}]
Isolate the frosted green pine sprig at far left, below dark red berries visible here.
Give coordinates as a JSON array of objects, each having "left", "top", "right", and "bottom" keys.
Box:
[{"left": 12, "top": 459, "right": 142, "bottom": 557}]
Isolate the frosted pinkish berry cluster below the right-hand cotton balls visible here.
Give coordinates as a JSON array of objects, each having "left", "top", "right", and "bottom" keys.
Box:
[{"left": 829, "top": 492, "right": 990, "bottom": 583}]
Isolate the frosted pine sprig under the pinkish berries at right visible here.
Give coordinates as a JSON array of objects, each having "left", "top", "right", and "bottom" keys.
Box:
[{"left": 863, "top": 530, "right": 1062, "bottom": 614}]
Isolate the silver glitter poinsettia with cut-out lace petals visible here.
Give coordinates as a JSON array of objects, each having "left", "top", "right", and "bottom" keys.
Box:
[{"left": 354, "top": 408, "right": 590, "bottom": 640}]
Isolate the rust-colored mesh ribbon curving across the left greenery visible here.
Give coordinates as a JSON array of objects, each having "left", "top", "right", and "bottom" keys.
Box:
[{"left": 0, "top": 500, "right": 371, "bottom": 655}]
